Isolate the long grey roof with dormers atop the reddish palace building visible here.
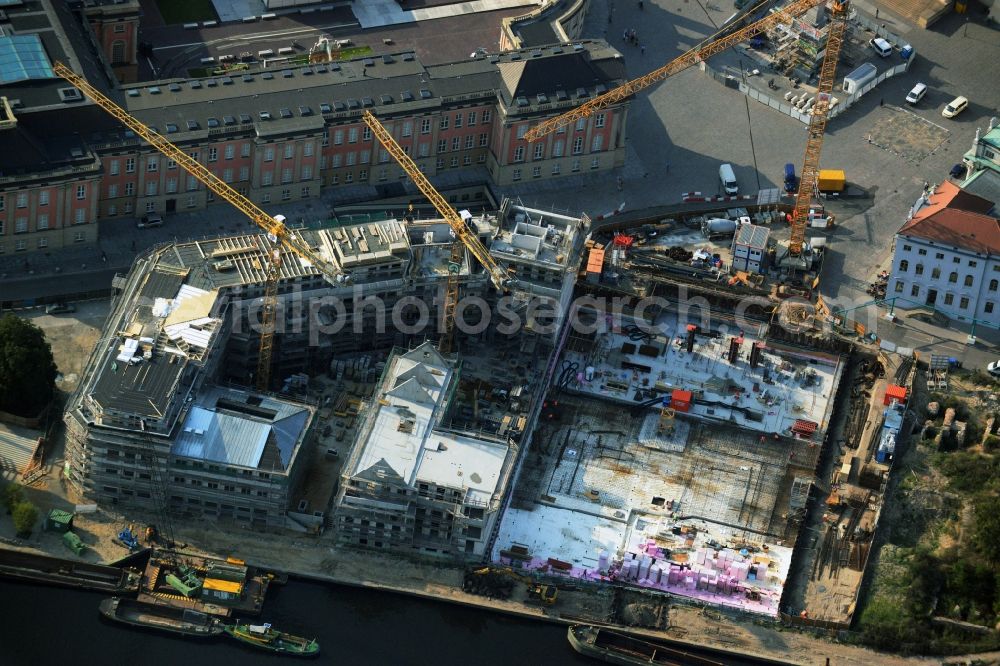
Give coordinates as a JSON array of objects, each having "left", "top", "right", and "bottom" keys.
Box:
[{"left": 124, "top": 41, "right": 624, "bottom": 140}]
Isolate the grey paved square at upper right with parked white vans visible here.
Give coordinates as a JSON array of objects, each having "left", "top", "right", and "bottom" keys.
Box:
[{"left": 519, "top": 0, "right": 1000, "bottom": 366}]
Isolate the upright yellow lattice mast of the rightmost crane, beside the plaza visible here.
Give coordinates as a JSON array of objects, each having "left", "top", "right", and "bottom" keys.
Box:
[{"left": 788, "top": 0, "right": 847, "bottom": 257}]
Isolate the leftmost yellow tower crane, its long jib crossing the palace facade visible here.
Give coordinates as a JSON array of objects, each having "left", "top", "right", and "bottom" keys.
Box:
[{"left": 52, "top": 62, "right": 343, "bottom": 391}]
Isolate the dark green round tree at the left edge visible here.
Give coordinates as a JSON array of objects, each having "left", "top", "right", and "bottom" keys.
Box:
[{"left": 0, "top": 314, "right": 56, "bottom": 417}]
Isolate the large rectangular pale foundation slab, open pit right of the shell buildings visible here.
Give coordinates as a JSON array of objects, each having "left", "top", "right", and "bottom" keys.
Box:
[{"left": 494, "top": 298, "right": 844, "bottom": 616}]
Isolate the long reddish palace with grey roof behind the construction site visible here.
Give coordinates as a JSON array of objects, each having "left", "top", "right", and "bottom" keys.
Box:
[{"left": 0, "top": 35, "right": 628, "bottom": 260}]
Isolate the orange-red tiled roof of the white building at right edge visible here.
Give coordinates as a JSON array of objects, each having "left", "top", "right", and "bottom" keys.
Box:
[{"left": 899, "top": 182, "right": 1000, "bottom": 254}]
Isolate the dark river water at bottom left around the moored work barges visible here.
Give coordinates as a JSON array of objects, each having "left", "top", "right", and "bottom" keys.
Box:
[{"left": 0, "top": 579, "right": 599, "bottom": 666}]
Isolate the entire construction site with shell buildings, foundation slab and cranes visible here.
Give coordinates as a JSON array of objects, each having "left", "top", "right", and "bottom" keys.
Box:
[{"left": 21, "top": 0, "right": 920, "bottom": 644}]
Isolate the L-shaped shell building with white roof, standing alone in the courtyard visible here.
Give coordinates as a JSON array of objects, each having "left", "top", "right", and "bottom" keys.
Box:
[{"left": 334, "top": 343, "right": 514, "bottom": 556}]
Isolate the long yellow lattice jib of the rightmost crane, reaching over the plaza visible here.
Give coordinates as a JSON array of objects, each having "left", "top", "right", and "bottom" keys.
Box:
[{"left": 524, "top": 0, "right": 837, "bottom": 142}]
